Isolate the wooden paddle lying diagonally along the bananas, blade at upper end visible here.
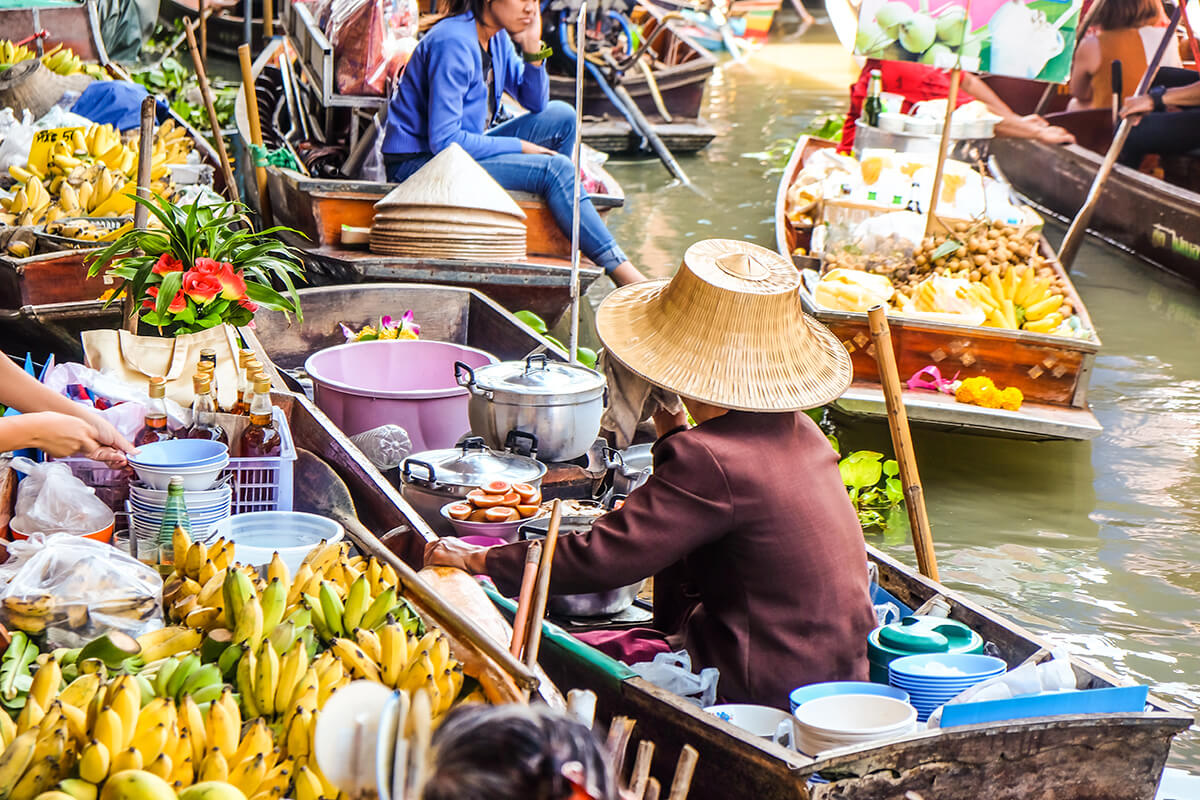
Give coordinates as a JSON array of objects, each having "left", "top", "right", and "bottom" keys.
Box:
[{"left": 295, "top": 447, "right": 540, "bottom": 690}]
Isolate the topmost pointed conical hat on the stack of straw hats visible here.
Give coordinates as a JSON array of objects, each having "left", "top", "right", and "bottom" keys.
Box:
[{"left": 376, "top": 144, "right": 524, "bottom": 219}]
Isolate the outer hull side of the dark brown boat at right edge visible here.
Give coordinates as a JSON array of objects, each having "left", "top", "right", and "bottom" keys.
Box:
[{"left": 991, "top": 139, "right": 1200, "bottom": 287}]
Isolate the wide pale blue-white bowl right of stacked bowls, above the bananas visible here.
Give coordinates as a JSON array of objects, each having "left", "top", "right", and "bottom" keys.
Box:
[{"left": 206, "top": 511, "right": 346, "bottom": 575}]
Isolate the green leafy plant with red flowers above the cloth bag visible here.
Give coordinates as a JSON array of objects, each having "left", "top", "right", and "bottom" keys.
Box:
[{"left": 88, "top": 196, "right": 304, "bottom": 336}]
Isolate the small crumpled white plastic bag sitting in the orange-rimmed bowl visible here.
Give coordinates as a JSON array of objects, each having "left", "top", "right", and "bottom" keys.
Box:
[{"left": 11, "top": 458, "right": 113, "bottom": 535}]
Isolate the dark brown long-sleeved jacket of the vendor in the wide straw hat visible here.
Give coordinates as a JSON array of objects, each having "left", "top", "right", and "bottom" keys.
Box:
[{"left": 487, "top": 411, "right": 875, "bottom": 708}]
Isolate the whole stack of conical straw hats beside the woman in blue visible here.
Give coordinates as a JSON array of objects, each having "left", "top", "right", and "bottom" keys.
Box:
[{"left": 371, "top": 144, "right": 526, "bottom": 261}]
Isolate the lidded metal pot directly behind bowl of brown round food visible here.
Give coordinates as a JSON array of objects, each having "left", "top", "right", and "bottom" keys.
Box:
[{"left": 400, "top": 437, "right": 546, "bottom": 536}]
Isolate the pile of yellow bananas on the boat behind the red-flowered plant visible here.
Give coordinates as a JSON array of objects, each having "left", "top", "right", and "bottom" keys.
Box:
[{"left": 0, "top": 120, "right": 192, "bottom": 231}]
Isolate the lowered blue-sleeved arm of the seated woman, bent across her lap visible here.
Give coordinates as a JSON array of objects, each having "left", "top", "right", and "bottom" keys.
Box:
[{"left": 427, "top": 40, "right": 522, "bottom": 161}]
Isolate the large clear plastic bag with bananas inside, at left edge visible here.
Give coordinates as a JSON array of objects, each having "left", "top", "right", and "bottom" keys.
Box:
[{"left": 0, "top": 534, "right": 162, "bottom": 648}]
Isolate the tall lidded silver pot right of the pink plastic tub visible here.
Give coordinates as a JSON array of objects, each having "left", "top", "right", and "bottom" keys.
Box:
[{"left": 455, "top": 354, "right": 606, "bottom": 462}]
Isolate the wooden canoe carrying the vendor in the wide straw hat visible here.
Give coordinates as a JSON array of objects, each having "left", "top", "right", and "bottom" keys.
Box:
[{"left": 276, "top": 383, "right": 1192, "bottom": 800}]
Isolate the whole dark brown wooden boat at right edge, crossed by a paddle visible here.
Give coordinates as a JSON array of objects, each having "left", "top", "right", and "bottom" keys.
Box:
[{"left": 989, "top": 79, "right": 1200, "bottom": 287}]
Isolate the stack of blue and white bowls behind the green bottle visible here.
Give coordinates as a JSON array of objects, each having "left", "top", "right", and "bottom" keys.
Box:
[{"left": 127, "top": 439, "right": 233, "bottom": 537}]
